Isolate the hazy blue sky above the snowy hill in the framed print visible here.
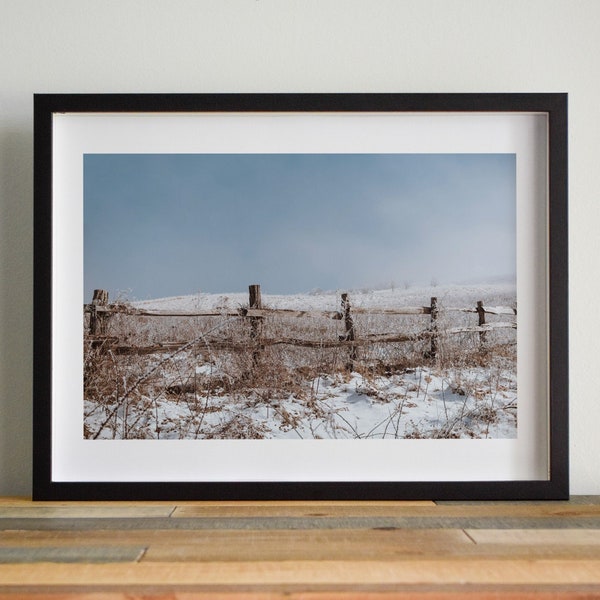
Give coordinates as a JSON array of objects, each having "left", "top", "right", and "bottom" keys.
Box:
[{"left": 84, "top": 154, "right": 516, "bottom": 299}]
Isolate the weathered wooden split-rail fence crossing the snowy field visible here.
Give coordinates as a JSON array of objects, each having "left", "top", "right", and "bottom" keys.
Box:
[{"left": 84, "top": 285, "right": 517, "bottom": 366}]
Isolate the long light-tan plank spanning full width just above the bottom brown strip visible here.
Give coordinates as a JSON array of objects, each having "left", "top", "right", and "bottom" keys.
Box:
[{"left": 0, "top": 559, "right": 600, "bottom": 589}]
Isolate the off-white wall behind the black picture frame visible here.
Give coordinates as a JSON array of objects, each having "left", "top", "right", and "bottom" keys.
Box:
[{"left": 0, "top": 0, "right": 600, "bottom": 495}]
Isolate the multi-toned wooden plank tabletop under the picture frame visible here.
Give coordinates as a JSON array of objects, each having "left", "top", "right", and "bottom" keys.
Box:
[{"left": 0, "top": 496, "right": 600, "bottom": 600}]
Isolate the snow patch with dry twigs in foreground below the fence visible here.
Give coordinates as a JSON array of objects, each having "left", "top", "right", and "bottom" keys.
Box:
[{"left": 86, "top": 368, "right": 517, "bottom": 439}]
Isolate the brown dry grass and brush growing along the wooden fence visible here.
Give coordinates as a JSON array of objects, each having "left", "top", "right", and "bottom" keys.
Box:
[{"left": 84, "top": 296, "right": 516, "bottom": 439}]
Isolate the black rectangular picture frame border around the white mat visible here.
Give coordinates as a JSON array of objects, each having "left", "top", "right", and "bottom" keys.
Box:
[{"left": 33, "top": 93, "right": 569, "bottom": 500}]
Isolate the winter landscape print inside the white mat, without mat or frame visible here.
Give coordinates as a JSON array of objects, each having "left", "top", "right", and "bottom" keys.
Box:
[{"left": 83, "top": 154, "right": 518, "bottom": 440}]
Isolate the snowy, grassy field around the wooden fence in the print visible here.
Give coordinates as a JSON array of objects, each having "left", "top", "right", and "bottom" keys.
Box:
[{"left": 84, "top": 283, "right": 517, "bottom": 439}]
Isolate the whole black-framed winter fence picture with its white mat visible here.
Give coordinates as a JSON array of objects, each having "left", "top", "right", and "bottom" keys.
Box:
[{"left": 33, "top": 93, "right": 569, "bottom": 500}]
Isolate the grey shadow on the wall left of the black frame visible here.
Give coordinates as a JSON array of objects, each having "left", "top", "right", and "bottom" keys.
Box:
[{"left": 0, "top": 123, "right": 33, "bottom": 496}]
